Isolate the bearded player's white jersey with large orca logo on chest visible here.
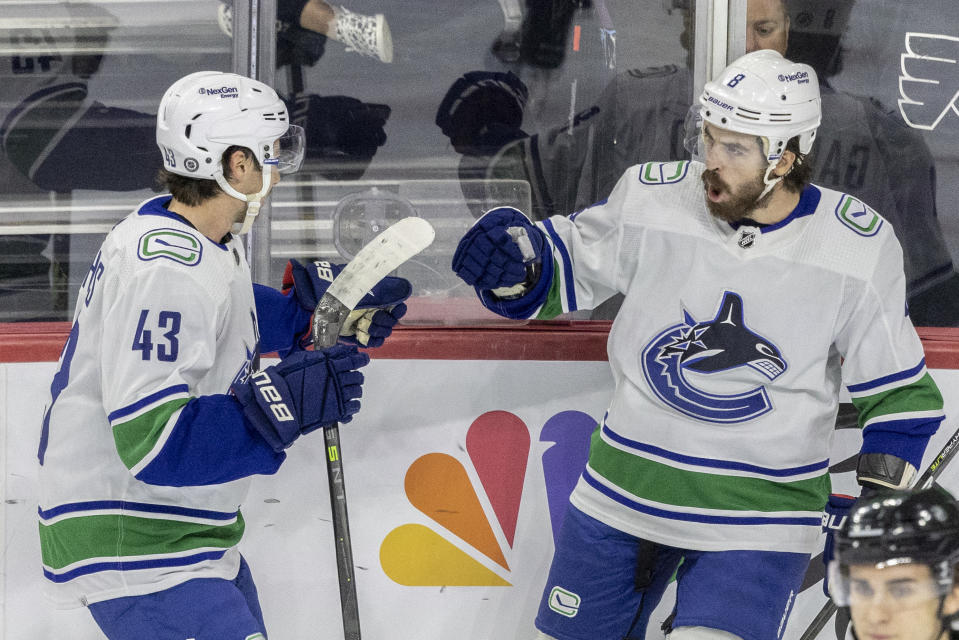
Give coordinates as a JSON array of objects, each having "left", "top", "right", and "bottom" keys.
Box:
[{"left": 520, "top": 162, "right": 943, "bottom": 553}]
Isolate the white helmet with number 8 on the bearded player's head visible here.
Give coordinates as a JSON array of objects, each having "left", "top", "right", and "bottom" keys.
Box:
[{"left": 699, "top": 49, "right": 822, "bottom": 163}]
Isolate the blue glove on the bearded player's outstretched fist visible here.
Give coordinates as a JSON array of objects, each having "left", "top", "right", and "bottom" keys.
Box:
[{"left": 453, "top": 207, "right": 546, "bottom": 293}]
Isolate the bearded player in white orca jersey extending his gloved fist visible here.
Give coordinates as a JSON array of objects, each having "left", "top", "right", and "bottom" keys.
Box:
[{"left": 453, "top": 50, "right": 943, "bottom": 640}]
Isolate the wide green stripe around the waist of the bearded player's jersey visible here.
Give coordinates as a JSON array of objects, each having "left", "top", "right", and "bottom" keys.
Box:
[{"left": 589, "top": 430, "right": 830, "bottom": 512}]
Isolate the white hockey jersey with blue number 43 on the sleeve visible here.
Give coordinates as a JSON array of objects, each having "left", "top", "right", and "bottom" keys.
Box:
[{"left": 39, "top": 196, "right": 272, "bottom": 606}]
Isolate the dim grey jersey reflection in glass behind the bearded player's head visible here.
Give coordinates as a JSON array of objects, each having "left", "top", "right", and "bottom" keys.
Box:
[{"left": 487, "top": 65, "right": 959, "bottom": 324}]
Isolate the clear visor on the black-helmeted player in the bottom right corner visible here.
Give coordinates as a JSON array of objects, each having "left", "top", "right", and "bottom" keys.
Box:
[{"left": 827, "top": 559, "right": 952, "bottom": 611}]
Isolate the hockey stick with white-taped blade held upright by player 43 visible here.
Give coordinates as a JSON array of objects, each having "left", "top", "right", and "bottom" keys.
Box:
[{"left": 313, "top": 218, "right": 435, "bottom": 640}]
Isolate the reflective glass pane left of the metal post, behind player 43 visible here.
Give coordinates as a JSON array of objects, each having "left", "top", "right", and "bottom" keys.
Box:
[{"left": 0, "top": 1, "right": 230, "bottom": 321}]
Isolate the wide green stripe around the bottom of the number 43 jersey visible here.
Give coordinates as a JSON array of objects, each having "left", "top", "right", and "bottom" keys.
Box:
[{"left": 40, "top": 512, "right": 245, "bottom": 570}]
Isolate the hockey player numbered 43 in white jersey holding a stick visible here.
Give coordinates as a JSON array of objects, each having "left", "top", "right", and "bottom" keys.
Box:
[{"left": 39, "top": 71, "right": 409, "bottom": 640}]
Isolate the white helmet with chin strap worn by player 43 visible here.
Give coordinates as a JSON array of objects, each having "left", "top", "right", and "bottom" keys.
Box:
[{"left": 156, "top": 71, "right": 306, "bottom": 233}]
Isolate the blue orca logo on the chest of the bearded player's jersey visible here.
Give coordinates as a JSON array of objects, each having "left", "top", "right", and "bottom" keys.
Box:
[{"left": 642, "top": 291, "right": 786, "bottom": 423}]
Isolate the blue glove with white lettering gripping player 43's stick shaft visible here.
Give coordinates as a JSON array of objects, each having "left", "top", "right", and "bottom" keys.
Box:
[{"left": 233, "top": 345, "right": 370, "bottom": 452}]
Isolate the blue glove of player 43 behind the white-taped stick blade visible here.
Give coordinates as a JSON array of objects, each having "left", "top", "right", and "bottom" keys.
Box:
[{"left": 282, "top": 260, "right": 413, "bottom": 347}]
